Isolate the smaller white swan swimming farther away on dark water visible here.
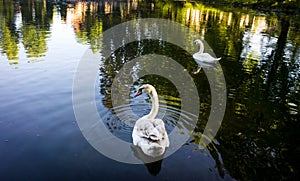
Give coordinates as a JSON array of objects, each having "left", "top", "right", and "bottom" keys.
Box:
[{"left": 193, "top": 39, "right": 221, "bottom": 71}]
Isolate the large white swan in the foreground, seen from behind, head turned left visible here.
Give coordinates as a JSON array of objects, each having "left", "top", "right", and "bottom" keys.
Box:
[{"left": 132, "top": 84, "right": 170, "bottom": 157}]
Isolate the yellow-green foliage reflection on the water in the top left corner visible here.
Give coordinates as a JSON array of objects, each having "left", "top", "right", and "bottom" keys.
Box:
[{"left": 0, "top": 0, "right": 52, "bottom": 60}]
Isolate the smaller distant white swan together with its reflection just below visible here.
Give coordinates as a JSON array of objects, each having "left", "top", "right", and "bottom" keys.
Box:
[{"left": 193, "top": 39, "right": 221, "bottom": 74}]
